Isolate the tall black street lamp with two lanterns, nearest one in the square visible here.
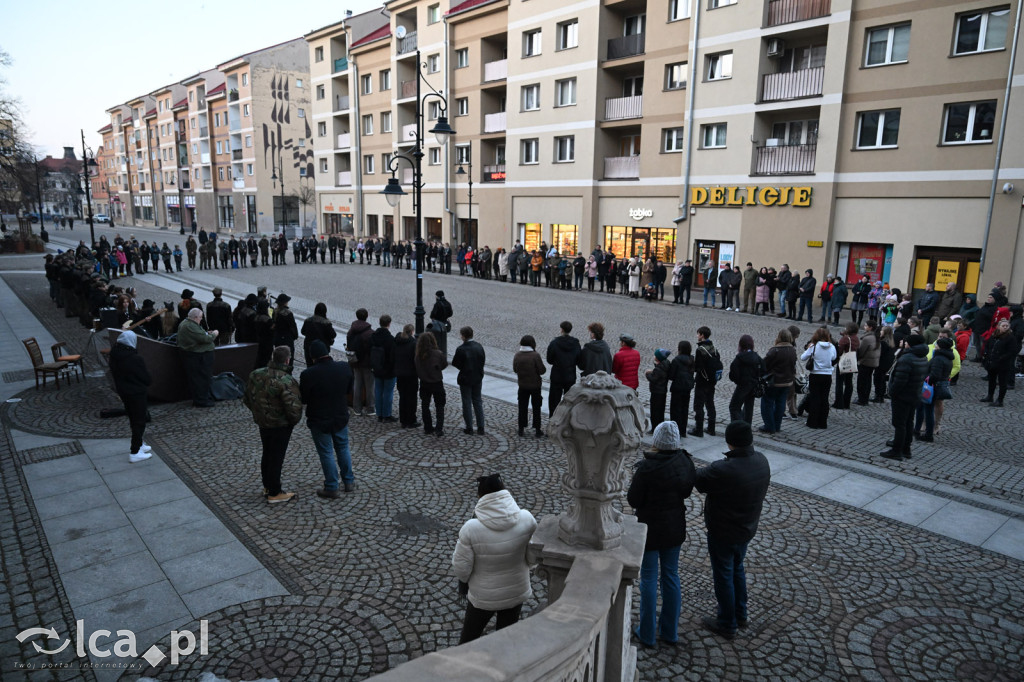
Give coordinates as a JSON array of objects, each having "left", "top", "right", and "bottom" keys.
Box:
[{"left": 380, "top": 50, "right": 455, "bottom": 334}]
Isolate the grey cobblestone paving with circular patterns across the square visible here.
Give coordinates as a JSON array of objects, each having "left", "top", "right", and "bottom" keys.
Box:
[{"left": 6, "top": 241, "right": 1024, "bottom": 680}]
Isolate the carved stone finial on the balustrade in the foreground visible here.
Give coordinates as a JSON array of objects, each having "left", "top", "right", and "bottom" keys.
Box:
[{"left": 548, "top": 372, "right": 646, "bottom": 549}]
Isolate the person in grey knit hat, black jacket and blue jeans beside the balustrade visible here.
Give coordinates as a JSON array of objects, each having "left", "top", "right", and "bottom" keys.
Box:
[{"left": 627, "top": 421, "right": 696, "bottom": 647}]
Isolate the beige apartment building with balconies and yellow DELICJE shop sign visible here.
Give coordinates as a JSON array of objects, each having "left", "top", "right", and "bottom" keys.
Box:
[{"left": 306, "top": 0, "right": 1024, "bottom": 299}]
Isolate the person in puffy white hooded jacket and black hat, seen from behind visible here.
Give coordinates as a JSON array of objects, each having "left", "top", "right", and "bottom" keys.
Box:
[{"left": 452, "top": 474, "right": 537, "bottom": 644}]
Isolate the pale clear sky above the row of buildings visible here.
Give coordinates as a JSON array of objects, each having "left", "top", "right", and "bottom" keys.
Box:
[{"left": 0, "top": 0, "right": 383, "bottom": 157}]
